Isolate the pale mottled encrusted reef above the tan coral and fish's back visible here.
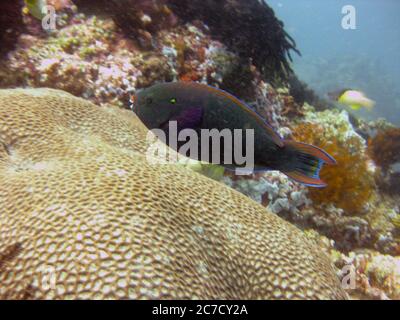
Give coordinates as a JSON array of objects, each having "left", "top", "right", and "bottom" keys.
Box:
[{"left": 0, "top": 8, "right": 256, "bottom": 107}]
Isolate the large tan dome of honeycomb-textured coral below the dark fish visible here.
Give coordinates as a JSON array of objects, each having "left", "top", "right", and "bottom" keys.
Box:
[{"left": 0, "top": 89, "right": 346, "bottom": 299}]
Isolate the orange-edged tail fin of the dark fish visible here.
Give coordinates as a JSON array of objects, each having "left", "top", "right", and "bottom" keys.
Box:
[{"left": 280, "top": 140, "right": 336, "bottom": 188}]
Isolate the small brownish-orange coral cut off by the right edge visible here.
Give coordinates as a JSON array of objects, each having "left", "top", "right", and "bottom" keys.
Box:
[{"left": 368, "top": 128, "right": 400, "bottom": 171}]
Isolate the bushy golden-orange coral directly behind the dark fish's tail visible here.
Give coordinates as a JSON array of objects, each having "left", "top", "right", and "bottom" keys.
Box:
[{"left": 292, "top": 123, "right": 374, "bottom": 214}]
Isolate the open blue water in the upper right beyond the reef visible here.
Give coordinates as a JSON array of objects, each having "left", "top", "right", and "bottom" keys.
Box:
[{"left": 267, "top": 0, "right": 400, "bottom": 125}]
